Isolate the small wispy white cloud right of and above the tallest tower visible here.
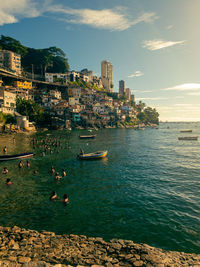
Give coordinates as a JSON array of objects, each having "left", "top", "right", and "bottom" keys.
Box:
[{"left": 142, "top": 40, "right": 186, "bottom": 51}]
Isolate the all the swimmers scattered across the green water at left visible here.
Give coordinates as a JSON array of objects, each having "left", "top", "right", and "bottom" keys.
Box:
[{"left": 2, "top": 135, "right": 70, "bottom": 204}]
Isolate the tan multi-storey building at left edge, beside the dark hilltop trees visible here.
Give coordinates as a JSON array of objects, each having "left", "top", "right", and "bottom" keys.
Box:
[{"left": 0, "top": 50, "right": 22, "bottom": 75}]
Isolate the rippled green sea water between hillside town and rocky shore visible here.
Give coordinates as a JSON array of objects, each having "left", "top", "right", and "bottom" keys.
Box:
[{"left": 0, "top": 123, "right": 200, "bottom": 253}]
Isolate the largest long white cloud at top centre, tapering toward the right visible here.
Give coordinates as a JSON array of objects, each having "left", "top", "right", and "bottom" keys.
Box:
[{"left": 48, "top": 5, "right": 158, "bottom": 31}]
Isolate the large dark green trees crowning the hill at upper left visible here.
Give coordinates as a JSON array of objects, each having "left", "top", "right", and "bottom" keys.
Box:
[{"left": 0, "top": 35, "right": 69, "bottom": 74}]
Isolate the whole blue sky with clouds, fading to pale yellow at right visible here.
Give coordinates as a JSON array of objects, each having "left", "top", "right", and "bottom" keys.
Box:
[{"left": 0, "top": 0, "right": 200, "bottom": 121}]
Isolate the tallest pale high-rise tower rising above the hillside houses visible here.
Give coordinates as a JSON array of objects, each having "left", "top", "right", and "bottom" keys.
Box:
[{"left": 101, "top": 60, "right": 113, "bottom": 93}]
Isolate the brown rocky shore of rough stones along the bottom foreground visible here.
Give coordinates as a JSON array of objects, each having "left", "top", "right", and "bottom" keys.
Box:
[{"left": 0, "top": 226, "right": 200, "bottom": 267}]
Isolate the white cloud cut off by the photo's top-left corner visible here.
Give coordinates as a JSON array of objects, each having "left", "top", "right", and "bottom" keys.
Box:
[{"left": 0, "top": 0, "right": 50, "bottom": 26}]
